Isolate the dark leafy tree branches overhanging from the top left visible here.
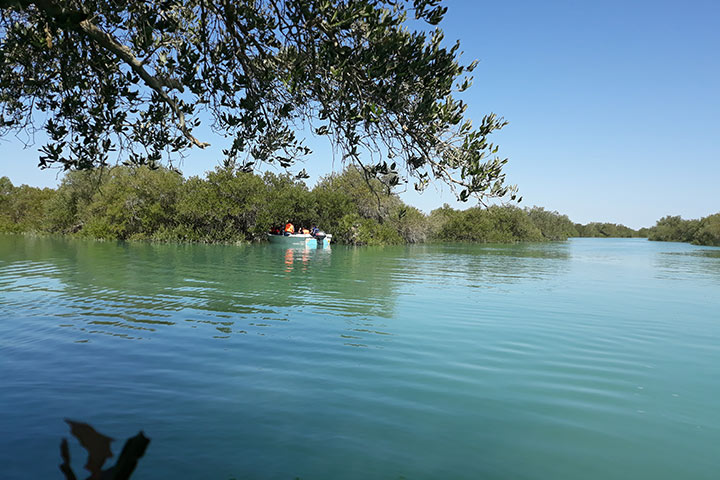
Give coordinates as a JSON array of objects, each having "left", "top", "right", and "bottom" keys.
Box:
[{"left": 0, "top": 0, "right": 515, "bottom": 200}]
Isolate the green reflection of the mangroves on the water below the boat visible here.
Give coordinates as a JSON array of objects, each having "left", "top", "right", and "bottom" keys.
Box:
[{"left": 0, "top": 236, "right": 398, "bottom": 339}]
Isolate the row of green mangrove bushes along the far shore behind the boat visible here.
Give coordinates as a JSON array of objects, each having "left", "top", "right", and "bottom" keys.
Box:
[{"left": 0, "top": 167, "right": 720, "bottom": 245}]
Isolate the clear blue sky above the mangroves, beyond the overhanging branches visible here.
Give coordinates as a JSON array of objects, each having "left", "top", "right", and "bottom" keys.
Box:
[{"left": 0, "top": 0, "right": 720, "bottom": 228}]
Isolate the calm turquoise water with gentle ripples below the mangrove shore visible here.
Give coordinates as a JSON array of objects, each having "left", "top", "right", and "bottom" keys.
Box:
[{"left": 0, "top": 236, "right": 720, "bottom": 480}]
